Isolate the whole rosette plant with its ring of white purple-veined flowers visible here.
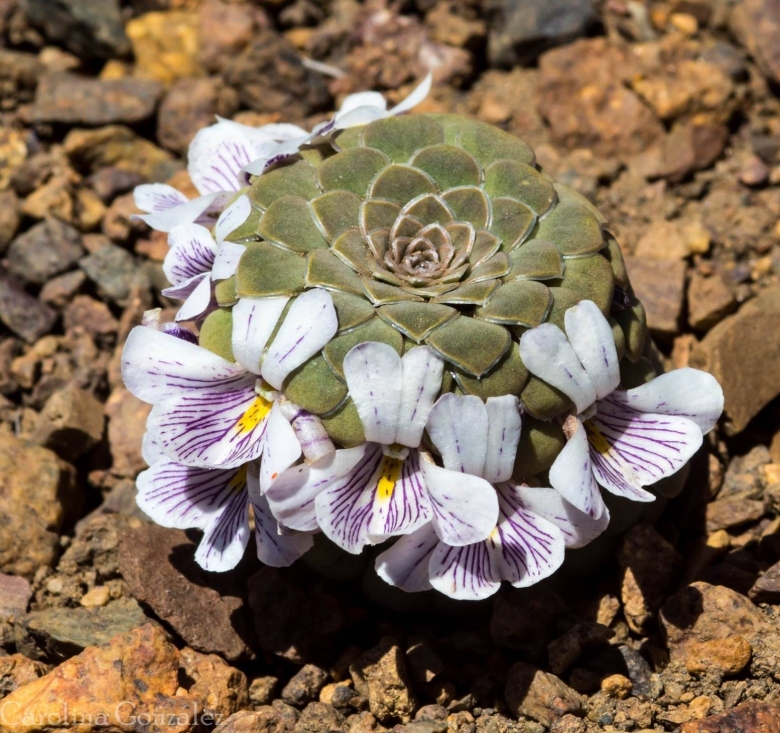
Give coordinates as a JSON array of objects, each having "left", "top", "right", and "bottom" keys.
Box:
[{"left": 122, "top": 80, "right": 723, "bottom": 599}]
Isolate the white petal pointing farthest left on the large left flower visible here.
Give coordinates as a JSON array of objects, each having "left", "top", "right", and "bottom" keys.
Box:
[{"left": 122, "top": 326, "right": 247, "bottom": 404}]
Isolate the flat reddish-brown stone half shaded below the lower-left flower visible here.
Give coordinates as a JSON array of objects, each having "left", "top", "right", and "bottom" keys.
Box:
[{"left": 119, "top": 525, "right": 249, "bottom": 661}]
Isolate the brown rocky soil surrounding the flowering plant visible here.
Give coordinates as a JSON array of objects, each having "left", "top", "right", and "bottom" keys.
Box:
[{"left": 0, "top": 0, "right": 780, "bottom": 733}]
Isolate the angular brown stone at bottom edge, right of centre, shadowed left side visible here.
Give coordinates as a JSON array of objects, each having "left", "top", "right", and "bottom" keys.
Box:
[{"left": 504, "top": 662, "right": 586, "bottom": 727}]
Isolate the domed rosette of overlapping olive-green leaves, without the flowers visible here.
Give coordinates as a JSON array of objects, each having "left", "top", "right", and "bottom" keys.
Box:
[{"left": 202, "top": 114, "right": 653, "bottom": 473}]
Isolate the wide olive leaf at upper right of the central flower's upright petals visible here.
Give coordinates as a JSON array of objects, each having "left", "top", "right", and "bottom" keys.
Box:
[{"left": 427, "top": 316, "right": 512, "bottom": 377}]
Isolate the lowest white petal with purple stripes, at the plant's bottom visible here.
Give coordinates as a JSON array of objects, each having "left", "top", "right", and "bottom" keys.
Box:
[{"left": 428, "top": 542, "right": 501, "bottom": 601}]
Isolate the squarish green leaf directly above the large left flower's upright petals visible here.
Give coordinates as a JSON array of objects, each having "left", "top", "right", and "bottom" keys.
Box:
[{"left": 236, "top": 242, "right": 306, "bottom": 298}]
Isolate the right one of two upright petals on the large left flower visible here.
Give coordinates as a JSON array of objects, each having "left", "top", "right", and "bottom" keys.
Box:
[{"left": 261, "top": 288, "right": 339, "bottom": 389}]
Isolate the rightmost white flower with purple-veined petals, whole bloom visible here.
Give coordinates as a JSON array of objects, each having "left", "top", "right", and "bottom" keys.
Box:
[{"left": 520, "top": 301, "right": 723, "bottom": 518}]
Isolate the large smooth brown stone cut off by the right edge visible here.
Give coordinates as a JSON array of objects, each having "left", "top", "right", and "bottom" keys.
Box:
[{"left": 690, "top": 286, "right": 780, "bottom": 435}]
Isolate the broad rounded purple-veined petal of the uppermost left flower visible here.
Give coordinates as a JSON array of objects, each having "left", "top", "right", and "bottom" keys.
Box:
[{"left": 187, "top": 122, "right": 255, "bottom": 194}]
